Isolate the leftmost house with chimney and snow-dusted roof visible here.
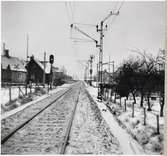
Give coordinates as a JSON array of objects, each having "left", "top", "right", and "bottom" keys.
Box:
[{"left": 1, "top": 49, "right": 27, "bottom": 84}]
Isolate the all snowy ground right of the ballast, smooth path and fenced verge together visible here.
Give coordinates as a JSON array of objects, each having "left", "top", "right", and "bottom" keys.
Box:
[{"left": 87, "top": 86, "right": 164, "bottom": 154}]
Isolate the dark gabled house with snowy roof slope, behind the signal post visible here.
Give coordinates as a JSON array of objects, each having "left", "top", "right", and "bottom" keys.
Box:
[{"left": 26, "top": 56, "right": 58, "bottom": 83}]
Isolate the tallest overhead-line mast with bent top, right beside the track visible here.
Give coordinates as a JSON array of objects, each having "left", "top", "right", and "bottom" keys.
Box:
[{"left": 96, "top": 11, "right": 119, "bottom": 100}]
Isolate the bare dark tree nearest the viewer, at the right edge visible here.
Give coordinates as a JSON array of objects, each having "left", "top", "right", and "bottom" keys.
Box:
[{"left": 131, "top": 49, "right": 165, "bottom": 111}]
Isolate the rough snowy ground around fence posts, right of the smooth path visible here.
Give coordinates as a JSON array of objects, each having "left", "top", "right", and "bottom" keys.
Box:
[{"left": 110, "top": 95, "right": 164, "bottom": 154}]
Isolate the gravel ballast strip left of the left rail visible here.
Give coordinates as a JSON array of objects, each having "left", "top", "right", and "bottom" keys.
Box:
[{"left": 1, "top": 87, "right": 73, "bottom": 141}]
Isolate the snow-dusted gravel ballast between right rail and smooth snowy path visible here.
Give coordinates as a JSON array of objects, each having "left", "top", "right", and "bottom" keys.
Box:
[{"left": 66, "top": 89, "right": 121, "bottom": 154}]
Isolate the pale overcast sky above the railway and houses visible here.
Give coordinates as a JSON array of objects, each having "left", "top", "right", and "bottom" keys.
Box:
[{"left": 1, "top": 1, "right": 165, "bottom": 78}]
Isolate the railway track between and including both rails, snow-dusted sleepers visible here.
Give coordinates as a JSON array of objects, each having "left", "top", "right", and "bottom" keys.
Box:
[{"left": 1, "top": 83, "right": 80, "bottom": 154}]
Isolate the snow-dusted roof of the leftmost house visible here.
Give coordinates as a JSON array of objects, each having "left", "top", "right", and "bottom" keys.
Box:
[{"left": 1, "top": 55, "right": 26, "bottom": 72}]
